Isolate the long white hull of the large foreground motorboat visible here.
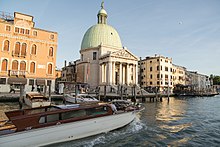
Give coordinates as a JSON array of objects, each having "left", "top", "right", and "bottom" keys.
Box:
[{"left": 0, "top": 112, "right": 135, "bottom": 147}]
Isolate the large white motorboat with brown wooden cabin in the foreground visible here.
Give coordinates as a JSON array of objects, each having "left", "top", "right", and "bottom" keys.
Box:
[{"left": 0, "top": 103, "right": 139, "bottom": 147}]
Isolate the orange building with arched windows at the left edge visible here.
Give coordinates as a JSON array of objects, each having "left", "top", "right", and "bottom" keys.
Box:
[{"left": 0, "top": 12, "right": 57, "bottom": 92}]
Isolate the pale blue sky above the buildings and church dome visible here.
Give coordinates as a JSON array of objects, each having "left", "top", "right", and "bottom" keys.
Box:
[{"left": 0, "top": 0, "right": 220, "bottom": 75}]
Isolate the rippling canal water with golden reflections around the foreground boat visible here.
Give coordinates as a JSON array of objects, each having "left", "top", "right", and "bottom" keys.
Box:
[{"left": 0, "top": 95, "right": 220, "bottom": 147}]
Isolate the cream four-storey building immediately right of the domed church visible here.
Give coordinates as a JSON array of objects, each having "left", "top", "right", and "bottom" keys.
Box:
[{"left": 139, "top": 55, "right": 173, "bottom": 93}]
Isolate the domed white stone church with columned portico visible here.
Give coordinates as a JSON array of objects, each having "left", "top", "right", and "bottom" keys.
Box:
[{"left": 76, "top": 3, "right": 138, "bottom": 87}]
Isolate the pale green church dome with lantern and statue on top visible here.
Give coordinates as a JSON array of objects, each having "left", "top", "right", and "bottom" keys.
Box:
[{"left": 81, "top": 2, "right": 122, "bottom": 50}]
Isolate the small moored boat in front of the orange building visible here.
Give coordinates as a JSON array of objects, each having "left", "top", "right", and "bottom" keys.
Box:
[{"left": 24, "top": 92, "right": 51, "bottom": 108}]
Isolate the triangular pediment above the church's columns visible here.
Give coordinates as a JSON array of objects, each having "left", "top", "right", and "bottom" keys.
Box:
[{"left": 110, "top": 49, "right": 138, "bottom": 60}]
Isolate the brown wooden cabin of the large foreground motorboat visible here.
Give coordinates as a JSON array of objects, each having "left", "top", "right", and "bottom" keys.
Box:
[{"left": 1, "top": 104, "right": 113, "bottom": 132}]
